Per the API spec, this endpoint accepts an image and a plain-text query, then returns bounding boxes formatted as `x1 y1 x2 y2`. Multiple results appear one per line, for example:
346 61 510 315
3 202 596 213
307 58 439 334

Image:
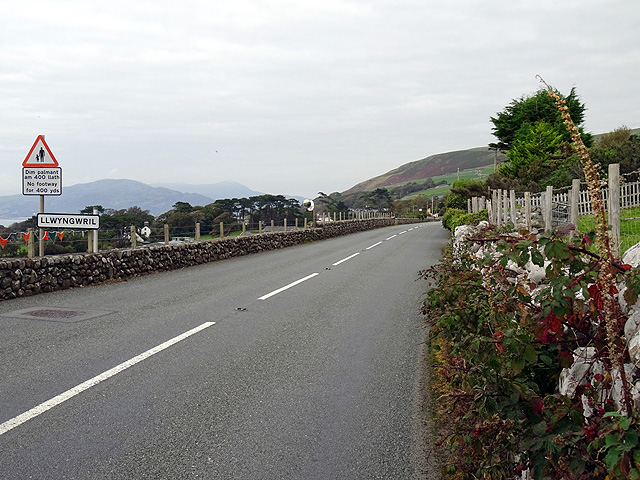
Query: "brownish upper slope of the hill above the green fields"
342 147 506 196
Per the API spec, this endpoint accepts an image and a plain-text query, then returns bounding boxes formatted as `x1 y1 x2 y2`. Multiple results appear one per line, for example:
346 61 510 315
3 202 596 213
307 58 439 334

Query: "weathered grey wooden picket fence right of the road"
468 164 640 256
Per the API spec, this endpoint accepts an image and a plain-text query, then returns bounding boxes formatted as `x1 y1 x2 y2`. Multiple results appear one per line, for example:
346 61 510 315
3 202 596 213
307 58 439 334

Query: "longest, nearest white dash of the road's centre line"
0 322 215 435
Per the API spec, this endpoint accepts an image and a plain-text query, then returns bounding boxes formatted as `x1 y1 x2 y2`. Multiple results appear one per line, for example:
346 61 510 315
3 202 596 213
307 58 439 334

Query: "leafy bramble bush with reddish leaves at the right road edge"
424 231 640 480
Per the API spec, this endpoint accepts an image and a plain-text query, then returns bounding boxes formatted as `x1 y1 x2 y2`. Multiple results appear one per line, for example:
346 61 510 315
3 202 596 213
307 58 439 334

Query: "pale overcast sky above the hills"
0 0 640 198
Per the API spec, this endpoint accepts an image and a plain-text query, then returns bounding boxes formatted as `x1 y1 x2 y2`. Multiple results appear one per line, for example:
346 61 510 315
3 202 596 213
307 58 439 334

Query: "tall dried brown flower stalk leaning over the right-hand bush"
538 76 631 413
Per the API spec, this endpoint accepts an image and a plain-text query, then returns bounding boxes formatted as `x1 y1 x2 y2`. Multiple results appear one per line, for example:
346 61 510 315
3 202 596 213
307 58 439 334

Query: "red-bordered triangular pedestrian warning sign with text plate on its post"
22 135 62 257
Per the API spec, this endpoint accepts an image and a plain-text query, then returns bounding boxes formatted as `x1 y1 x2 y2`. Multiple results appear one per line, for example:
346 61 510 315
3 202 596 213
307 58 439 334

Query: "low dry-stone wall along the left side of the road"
0 218 416 301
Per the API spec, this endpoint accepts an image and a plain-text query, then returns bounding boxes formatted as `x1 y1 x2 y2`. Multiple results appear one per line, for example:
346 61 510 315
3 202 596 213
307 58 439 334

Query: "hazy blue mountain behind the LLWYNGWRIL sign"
0 180 215 218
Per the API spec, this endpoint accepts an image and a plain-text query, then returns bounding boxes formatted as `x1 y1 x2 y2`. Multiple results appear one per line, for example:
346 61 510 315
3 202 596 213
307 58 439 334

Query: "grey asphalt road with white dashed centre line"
0 223 448 480
